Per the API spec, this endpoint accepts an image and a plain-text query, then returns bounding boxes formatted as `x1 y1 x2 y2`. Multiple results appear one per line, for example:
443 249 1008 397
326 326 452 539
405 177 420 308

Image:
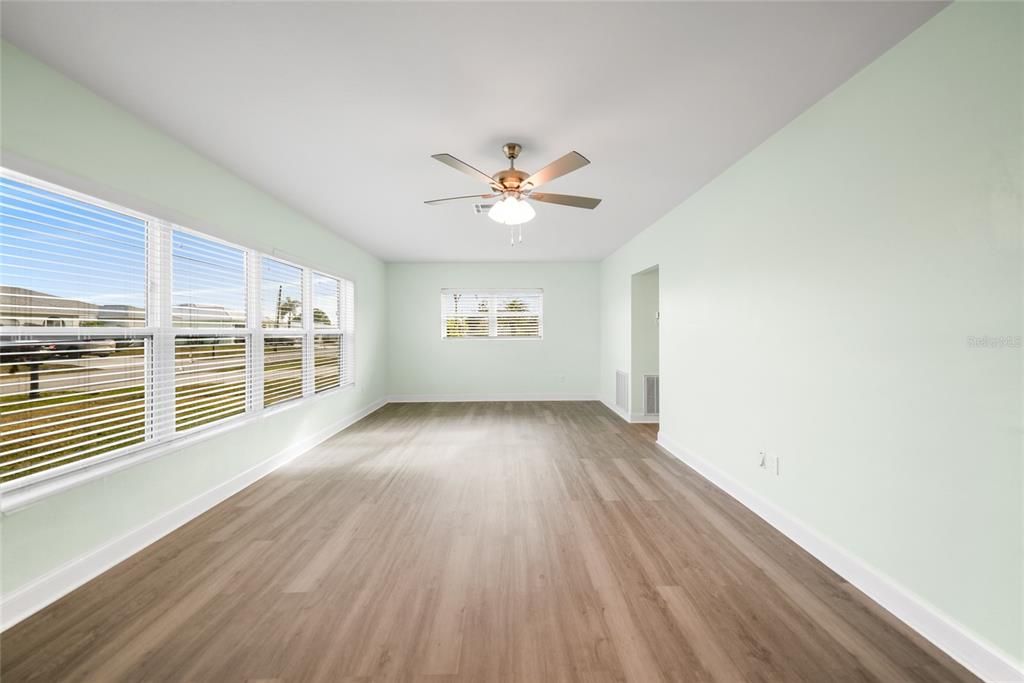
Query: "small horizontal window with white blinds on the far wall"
441 290 544 339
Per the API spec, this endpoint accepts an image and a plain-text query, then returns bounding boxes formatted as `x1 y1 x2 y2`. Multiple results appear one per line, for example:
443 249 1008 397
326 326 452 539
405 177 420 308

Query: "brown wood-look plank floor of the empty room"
2 402 976 683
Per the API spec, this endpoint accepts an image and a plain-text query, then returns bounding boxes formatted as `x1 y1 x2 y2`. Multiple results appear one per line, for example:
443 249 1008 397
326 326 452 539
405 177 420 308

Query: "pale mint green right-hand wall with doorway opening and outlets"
600 3 1024 663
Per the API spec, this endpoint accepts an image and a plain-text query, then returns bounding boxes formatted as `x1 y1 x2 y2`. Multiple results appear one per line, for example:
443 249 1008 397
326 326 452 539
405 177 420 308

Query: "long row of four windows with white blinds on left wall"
0 169 354 488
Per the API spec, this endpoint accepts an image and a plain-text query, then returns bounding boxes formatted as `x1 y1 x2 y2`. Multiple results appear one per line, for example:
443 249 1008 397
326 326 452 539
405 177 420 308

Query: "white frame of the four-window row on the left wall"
0 167 355 501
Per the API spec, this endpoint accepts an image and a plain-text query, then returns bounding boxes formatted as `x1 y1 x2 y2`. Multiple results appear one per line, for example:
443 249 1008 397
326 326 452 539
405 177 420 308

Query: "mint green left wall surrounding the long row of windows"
0 44 387 592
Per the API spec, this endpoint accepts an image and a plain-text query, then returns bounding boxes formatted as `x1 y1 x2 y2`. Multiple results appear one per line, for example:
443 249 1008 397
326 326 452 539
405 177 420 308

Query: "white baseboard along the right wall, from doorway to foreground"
657 432 1024 683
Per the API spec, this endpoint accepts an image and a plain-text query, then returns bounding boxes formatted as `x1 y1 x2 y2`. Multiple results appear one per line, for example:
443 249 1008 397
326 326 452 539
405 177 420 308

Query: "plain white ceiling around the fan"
2 2 944 261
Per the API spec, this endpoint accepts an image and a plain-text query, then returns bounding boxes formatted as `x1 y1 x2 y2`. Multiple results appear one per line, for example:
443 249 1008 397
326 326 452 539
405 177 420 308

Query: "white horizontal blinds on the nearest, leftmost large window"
0 177 152 481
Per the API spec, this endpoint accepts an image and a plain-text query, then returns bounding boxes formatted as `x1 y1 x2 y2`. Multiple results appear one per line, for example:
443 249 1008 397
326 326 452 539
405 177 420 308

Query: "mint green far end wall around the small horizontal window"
388 263 598 398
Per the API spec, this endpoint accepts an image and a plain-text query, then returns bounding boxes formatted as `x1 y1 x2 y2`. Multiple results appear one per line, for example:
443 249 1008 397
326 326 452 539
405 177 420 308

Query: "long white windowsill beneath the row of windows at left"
0 382 355 514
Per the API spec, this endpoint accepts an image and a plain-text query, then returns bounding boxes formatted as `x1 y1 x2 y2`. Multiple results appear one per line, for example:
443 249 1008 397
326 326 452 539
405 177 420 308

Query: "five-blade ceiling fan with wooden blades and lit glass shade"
424 142 601 225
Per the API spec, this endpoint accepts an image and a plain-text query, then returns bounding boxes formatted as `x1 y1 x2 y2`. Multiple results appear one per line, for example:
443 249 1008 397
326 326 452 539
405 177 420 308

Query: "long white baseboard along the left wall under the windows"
0 399 387 631
